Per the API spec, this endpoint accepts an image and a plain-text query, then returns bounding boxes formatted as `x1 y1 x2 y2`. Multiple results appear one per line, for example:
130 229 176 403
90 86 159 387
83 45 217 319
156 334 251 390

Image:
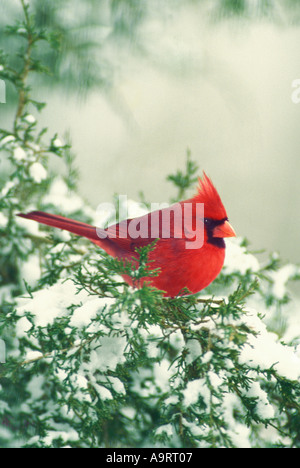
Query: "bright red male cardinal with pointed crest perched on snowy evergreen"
18 173 235 297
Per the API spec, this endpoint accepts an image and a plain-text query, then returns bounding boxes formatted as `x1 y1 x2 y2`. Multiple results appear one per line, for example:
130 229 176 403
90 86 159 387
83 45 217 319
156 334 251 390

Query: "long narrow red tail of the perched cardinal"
17 211 99 242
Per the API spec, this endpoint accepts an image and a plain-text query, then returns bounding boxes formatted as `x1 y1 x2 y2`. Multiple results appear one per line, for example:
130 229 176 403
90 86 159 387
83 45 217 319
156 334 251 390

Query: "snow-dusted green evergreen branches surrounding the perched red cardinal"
0 0 300 448
